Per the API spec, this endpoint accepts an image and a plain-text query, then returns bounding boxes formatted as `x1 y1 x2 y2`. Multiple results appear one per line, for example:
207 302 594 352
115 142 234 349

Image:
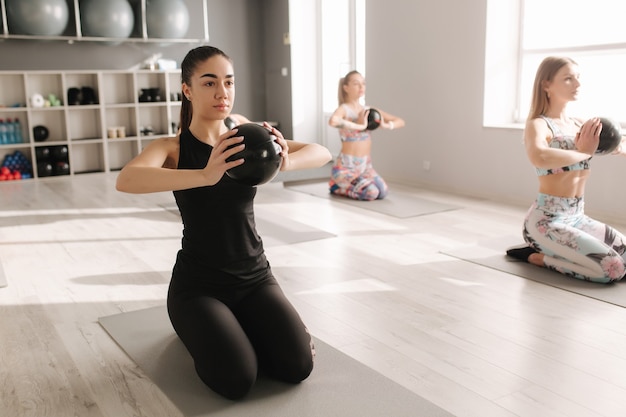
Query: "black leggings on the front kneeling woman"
167 280 314 400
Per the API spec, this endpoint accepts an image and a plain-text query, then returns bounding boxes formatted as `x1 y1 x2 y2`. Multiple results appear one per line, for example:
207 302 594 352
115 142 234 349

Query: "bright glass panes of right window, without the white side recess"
519 0 626 121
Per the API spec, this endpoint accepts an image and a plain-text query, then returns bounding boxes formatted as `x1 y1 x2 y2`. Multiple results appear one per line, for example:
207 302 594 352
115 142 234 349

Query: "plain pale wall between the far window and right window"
366 0 626 223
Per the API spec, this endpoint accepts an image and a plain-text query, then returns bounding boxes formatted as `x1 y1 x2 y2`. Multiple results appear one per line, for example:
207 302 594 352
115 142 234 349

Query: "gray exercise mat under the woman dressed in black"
99 306 452 417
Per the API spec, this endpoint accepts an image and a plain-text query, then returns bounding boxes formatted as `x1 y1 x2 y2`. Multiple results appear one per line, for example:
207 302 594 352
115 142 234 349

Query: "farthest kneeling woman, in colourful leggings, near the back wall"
328 71 404 200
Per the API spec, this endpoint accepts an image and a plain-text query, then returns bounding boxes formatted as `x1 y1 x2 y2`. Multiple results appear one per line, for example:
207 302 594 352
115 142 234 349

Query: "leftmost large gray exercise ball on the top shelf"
6 0 69 36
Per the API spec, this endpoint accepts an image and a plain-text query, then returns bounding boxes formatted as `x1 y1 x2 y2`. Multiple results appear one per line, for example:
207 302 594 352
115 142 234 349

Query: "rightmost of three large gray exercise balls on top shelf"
146 0 189 39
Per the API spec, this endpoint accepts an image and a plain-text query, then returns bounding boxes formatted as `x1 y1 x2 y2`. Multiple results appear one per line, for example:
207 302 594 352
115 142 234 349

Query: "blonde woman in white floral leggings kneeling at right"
507 57 626 283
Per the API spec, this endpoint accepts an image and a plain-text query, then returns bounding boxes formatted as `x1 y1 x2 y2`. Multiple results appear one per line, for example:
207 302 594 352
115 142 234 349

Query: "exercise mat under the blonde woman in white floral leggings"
442 236 626 307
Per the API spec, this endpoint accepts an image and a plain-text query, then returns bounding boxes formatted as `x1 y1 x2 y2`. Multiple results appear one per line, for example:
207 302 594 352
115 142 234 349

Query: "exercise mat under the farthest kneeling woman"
285 181 460 219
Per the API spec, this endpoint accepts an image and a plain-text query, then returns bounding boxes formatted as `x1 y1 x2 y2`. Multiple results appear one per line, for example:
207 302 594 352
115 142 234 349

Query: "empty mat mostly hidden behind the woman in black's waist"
162 204 337 247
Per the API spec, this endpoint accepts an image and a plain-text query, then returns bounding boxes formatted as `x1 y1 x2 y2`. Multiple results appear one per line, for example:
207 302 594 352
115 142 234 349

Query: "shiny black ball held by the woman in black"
226 123 283 186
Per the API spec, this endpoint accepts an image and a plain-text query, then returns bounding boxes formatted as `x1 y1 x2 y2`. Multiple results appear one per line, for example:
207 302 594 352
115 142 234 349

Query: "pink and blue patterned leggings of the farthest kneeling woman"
328 153 388 201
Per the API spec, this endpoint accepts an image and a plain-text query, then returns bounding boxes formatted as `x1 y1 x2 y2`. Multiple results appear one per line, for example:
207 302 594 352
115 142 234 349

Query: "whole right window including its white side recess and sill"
484 0 626 126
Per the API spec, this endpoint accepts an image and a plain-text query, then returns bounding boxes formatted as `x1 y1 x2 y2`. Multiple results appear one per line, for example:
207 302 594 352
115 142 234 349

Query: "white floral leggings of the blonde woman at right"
523 193 626 283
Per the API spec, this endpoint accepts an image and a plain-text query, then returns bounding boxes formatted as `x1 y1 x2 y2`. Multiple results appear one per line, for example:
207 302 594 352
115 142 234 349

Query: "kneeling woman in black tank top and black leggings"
116 46 332 399
